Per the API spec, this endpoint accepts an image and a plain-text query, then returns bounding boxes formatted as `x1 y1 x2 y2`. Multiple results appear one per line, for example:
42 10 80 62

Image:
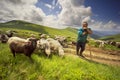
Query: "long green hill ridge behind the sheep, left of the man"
0 20 77 38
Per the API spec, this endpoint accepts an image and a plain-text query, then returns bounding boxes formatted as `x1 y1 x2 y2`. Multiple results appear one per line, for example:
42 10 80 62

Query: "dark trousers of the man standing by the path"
76 41 86 55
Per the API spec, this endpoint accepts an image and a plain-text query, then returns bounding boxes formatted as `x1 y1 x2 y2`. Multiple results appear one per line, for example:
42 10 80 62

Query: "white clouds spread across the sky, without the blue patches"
0 0 119 30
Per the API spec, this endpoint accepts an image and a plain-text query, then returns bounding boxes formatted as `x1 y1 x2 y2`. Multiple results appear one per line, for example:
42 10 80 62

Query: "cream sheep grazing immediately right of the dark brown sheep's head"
37 38 51 57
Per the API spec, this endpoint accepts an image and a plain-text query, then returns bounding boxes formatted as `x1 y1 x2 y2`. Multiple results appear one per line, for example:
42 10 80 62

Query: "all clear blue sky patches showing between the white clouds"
36 0 120 24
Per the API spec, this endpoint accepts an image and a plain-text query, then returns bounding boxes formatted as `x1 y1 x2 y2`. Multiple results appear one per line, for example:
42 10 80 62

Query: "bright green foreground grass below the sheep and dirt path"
0 44 120 80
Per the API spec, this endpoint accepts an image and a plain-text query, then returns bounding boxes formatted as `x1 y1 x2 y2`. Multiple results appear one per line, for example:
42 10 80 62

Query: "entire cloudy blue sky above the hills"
0 0 120 31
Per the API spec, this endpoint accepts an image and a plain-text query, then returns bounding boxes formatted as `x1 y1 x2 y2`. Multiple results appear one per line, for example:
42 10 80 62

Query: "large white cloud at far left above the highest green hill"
0 0 45 23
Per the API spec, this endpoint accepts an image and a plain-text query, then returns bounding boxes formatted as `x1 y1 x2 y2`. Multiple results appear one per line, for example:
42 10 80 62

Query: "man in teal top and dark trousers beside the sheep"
76 22 92 57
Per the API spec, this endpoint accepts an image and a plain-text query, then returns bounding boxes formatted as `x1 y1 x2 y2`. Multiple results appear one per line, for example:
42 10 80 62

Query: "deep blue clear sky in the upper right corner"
84 0 120 23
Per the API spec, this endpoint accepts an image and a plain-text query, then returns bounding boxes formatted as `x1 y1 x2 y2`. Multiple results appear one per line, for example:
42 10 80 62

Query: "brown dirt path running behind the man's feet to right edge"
65 46 120 66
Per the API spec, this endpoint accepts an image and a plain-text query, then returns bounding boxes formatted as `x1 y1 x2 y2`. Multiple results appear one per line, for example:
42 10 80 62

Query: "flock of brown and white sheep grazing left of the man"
0 31 72 58
